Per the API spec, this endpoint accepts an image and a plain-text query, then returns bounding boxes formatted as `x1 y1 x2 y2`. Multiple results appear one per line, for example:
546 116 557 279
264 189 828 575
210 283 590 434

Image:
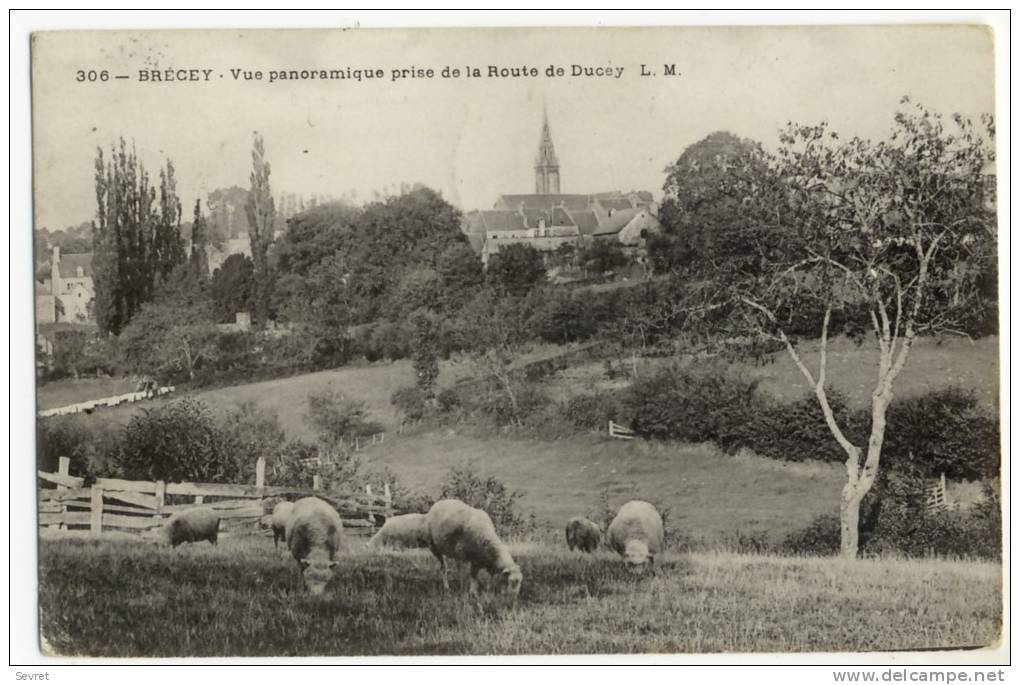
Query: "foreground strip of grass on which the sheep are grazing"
40 536 1002 656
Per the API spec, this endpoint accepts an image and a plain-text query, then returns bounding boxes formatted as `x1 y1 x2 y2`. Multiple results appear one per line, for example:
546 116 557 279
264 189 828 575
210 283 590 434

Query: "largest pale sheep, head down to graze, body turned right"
426 499 523 599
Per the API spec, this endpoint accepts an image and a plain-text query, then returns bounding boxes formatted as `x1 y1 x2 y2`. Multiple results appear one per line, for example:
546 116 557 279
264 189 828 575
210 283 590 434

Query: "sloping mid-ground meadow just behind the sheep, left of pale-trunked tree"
363 431 846 543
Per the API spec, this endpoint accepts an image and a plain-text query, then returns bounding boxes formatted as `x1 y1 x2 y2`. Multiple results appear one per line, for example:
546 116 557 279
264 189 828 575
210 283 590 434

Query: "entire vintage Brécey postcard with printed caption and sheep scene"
17 17 1009 664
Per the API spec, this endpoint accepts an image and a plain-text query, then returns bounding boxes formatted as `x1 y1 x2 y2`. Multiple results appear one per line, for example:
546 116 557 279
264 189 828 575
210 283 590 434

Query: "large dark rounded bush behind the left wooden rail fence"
116 399 242 483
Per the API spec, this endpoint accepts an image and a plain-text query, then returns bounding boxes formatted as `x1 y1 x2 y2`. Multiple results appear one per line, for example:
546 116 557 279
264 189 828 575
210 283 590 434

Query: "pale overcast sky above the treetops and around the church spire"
33 27 993 229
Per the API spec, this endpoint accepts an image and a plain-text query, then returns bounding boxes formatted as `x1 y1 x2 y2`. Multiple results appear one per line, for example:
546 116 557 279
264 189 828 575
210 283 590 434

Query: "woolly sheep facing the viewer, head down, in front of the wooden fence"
286 497 344 594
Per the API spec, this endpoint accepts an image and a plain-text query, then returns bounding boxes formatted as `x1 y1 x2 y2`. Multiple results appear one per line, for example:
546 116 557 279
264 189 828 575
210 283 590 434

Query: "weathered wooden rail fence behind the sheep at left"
37 457 393 537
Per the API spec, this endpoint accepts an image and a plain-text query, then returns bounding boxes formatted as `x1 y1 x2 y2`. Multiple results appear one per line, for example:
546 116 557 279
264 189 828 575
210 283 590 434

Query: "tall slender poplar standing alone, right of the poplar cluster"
245 133 276 326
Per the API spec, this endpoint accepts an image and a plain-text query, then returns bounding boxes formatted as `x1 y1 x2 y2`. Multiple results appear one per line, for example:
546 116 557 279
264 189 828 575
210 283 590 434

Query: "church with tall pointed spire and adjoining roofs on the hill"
462 113 662 263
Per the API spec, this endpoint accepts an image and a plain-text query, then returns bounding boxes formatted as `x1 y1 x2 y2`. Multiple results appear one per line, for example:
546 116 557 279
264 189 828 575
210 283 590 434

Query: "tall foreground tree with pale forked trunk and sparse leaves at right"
719 99 996 557
